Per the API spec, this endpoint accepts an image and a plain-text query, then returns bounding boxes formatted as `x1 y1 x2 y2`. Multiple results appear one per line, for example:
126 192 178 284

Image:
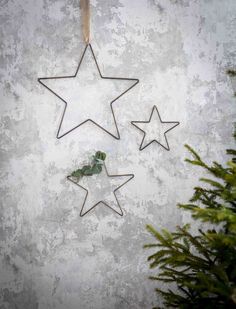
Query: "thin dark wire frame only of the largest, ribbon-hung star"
38 43 139 140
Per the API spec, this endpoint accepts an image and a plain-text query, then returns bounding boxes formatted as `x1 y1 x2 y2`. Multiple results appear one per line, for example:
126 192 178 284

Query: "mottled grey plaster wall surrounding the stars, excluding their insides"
0 0 236 309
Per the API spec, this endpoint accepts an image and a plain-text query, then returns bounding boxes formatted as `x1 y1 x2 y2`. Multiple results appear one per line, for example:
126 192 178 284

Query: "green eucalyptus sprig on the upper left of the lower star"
71 151 106 179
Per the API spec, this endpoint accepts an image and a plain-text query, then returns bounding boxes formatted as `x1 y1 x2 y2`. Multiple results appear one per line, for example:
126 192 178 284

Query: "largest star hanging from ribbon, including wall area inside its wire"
38 44 139 139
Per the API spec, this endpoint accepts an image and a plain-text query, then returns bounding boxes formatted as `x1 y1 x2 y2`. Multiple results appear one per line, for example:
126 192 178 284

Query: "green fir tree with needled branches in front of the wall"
145 74 236 309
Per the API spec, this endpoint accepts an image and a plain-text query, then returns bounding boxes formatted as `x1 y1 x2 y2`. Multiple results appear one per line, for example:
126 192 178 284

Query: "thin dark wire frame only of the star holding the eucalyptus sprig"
66 164 134 217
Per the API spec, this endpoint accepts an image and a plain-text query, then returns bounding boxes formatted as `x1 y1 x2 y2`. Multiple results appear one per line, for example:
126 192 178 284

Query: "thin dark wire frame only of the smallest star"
131 105 180 151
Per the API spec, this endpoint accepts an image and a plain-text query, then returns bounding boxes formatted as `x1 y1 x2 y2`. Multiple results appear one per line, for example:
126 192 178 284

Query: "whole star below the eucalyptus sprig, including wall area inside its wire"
67 164 134 217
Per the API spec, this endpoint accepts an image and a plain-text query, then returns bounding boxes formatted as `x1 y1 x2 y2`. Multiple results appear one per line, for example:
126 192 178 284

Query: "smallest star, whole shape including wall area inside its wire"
131 105 179 150
